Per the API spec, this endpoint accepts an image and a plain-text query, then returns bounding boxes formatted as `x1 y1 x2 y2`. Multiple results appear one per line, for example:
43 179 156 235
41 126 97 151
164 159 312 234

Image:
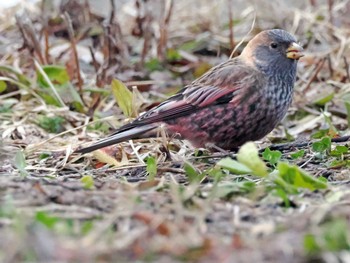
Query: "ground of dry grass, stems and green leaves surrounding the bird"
0 0 350 262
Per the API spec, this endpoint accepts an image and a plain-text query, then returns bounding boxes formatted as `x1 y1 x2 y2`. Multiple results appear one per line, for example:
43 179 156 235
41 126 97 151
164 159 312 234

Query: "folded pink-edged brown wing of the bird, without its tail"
114 60 260 131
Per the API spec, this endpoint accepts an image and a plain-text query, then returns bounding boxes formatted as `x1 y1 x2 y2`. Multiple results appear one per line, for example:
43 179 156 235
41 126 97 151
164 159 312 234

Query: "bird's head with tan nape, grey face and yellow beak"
241 29 304 74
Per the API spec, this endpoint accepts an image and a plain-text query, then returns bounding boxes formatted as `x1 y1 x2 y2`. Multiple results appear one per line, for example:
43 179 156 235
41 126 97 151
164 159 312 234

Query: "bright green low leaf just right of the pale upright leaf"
277 162 327 191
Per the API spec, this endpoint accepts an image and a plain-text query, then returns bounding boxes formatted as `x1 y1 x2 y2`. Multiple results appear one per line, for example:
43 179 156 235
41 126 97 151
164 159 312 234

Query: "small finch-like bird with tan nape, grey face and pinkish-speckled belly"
76 29 304 153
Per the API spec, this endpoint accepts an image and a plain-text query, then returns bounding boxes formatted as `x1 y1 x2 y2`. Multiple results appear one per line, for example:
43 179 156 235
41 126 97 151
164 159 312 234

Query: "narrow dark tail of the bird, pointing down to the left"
75 124 158 153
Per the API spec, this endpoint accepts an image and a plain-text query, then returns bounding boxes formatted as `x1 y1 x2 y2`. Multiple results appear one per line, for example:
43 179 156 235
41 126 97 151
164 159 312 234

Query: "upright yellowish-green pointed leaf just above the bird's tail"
111 79 134 117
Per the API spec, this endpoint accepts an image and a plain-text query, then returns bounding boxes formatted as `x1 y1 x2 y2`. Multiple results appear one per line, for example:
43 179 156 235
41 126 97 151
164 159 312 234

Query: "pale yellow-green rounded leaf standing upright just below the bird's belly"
237 142 268 177
